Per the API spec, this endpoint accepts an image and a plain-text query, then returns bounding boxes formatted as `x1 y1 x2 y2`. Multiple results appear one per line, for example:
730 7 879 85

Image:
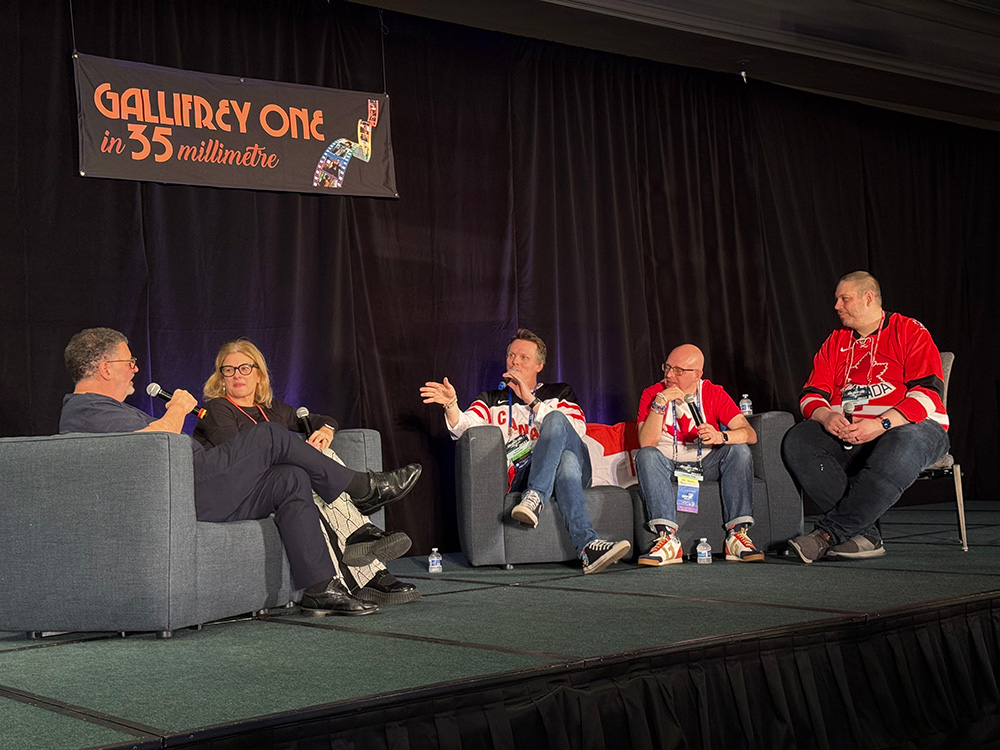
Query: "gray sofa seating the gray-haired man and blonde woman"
0 430 382 637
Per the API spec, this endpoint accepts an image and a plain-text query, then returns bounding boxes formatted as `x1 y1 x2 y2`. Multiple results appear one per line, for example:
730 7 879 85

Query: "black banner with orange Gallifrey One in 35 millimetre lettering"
75 55 398 198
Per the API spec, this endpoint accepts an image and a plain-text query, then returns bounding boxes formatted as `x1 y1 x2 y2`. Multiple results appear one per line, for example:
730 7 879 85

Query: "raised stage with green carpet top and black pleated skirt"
0 502 1000 750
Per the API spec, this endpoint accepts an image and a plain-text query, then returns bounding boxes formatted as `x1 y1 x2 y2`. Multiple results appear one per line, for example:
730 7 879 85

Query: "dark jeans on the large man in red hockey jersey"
781 419 951 544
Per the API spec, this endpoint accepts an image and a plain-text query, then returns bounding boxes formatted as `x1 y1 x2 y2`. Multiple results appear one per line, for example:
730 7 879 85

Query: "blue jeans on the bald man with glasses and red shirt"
635 444 753 533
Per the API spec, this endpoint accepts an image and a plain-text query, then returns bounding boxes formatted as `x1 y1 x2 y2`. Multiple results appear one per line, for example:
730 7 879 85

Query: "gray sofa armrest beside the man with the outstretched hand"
455 425 507 565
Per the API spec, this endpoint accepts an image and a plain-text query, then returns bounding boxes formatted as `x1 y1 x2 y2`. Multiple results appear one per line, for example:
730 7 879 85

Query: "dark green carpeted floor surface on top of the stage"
0 502 1000 750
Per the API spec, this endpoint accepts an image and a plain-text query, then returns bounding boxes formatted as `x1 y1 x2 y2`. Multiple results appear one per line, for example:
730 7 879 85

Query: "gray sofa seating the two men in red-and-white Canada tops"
455 412 802 565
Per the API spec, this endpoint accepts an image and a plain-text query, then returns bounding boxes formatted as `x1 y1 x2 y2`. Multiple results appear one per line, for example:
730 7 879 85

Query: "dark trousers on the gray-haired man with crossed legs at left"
194 422 355 588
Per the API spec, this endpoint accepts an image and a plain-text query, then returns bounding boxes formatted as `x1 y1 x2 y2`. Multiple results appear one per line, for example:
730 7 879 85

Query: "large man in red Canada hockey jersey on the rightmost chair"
782 271 949 563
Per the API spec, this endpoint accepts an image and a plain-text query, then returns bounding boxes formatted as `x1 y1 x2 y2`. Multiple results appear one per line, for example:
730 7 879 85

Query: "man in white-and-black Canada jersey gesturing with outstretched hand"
420 328 632 573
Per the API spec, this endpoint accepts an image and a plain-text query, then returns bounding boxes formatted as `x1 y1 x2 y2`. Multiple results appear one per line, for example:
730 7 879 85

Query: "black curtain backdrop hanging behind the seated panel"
0 0 1000 552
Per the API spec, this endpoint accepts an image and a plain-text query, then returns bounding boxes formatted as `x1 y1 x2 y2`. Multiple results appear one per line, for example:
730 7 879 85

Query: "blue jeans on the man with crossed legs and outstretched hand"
528 412 598 554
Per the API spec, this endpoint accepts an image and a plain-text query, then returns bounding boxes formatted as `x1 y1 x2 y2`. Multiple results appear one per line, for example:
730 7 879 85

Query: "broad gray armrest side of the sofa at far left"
0 432 196 630
